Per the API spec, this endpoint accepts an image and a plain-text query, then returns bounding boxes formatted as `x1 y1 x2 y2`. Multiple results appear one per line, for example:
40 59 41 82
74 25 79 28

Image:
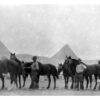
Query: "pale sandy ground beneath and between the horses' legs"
0 76 100 96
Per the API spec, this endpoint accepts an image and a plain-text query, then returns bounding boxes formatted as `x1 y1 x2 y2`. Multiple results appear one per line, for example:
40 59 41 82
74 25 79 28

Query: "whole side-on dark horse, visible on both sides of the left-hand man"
23 62 58 89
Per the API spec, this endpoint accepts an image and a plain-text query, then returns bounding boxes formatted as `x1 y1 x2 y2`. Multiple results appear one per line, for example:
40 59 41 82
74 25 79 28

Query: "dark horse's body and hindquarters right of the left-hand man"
34 62 59 89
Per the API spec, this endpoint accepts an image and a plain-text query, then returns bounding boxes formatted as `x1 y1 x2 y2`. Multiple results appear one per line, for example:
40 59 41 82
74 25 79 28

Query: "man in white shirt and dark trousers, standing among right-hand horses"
75 59 86 90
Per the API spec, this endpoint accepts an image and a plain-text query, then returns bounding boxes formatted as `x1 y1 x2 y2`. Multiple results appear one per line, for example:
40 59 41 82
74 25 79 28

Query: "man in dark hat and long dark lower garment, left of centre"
30 56 39 89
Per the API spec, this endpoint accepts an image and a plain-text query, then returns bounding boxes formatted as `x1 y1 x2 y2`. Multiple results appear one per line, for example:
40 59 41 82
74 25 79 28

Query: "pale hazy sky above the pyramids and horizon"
0 5 100 59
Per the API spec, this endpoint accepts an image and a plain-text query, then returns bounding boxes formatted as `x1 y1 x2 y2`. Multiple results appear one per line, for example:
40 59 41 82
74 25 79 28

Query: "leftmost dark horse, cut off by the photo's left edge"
0 58 19 89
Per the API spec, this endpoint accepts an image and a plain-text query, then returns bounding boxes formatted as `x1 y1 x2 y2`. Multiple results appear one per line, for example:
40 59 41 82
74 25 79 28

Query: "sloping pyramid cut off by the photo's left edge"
0 41 10 59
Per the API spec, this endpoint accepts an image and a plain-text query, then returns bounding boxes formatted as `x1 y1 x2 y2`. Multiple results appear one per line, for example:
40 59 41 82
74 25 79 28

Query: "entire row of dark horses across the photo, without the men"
0 53 100 90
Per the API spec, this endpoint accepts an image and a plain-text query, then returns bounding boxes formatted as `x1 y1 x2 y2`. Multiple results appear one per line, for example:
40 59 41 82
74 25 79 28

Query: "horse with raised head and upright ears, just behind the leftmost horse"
10 53 23 88
